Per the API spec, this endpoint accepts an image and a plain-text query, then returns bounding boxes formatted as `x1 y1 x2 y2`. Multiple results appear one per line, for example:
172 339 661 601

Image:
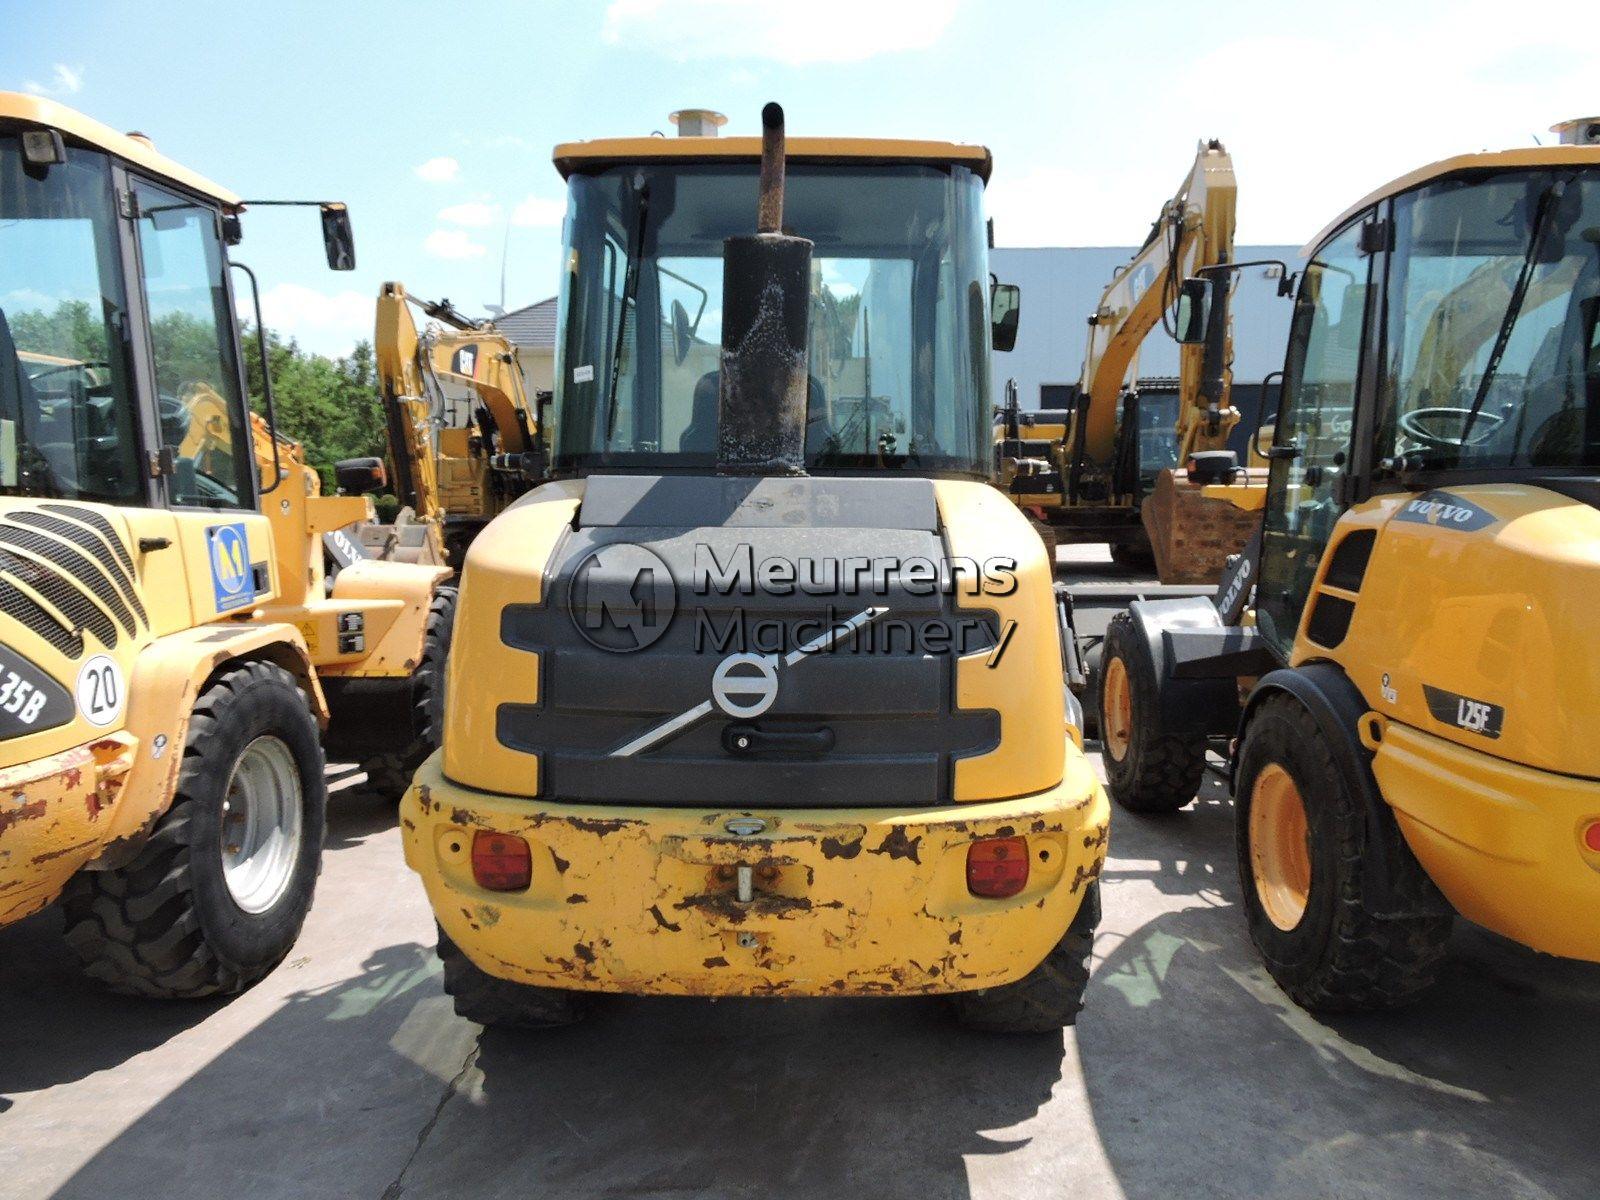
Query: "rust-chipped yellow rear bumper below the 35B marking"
0 734 133 925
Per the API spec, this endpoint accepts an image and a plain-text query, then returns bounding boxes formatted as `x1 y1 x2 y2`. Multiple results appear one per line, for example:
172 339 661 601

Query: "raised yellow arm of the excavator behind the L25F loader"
1069 141 1238 464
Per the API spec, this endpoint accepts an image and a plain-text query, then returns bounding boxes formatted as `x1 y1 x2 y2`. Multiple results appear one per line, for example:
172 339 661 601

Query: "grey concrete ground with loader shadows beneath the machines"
0 553 1600 1200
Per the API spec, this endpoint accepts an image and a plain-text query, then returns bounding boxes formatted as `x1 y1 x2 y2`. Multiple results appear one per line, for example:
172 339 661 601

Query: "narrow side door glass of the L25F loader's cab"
1256 222 1371 656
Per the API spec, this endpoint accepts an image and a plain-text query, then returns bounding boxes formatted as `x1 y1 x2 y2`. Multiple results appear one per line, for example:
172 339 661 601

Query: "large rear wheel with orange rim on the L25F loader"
1235 696 1453 1013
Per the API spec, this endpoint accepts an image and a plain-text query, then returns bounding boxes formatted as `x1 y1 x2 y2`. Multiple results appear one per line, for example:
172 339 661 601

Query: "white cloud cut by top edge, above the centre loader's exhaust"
602 0 960 66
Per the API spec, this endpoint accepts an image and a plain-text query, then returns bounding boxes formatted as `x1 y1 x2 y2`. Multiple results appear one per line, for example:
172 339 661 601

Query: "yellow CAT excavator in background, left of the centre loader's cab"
353 283 549 571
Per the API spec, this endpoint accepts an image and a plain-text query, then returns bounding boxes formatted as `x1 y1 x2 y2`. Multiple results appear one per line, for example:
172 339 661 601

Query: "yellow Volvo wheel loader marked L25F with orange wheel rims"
1101 120 1600 1010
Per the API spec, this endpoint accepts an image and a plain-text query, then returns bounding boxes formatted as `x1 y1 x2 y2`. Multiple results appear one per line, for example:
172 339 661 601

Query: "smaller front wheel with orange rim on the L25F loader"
1099 613 1206 813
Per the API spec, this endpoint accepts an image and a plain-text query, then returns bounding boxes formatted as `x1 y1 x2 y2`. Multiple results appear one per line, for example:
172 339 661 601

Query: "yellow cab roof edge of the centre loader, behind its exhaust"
552 138 992 182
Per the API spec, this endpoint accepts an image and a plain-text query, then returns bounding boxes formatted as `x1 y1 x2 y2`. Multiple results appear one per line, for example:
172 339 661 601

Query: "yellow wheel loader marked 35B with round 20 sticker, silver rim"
0 93 445 997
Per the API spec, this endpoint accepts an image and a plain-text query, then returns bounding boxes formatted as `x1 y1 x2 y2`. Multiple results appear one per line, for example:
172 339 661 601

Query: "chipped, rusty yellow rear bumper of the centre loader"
400 747 1109 995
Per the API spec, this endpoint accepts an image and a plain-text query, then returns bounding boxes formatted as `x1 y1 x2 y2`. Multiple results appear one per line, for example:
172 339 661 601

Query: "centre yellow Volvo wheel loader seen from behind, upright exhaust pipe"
402 104 1107 1030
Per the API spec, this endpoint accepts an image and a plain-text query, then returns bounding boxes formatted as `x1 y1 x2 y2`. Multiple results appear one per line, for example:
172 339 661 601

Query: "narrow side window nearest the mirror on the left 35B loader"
134 182 254 509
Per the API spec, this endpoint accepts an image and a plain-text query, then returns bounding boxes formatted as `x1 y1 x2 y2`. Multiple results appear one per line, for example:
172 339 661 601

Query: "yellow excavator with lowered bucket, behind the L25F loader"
995 141 1261 584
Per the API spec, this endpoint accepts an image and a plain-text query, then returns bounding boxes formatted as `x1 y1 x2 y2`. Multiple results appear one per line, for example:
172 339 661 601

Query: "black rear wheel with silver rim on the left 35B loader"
64 662 328 997
